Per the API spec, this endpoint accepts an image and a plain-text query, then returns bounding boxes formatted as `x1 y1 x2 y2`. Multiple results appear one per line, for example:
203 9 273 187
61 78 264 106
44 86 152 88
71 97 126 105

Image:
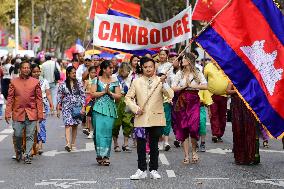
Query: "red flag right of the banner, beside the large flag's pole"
192 0 228 21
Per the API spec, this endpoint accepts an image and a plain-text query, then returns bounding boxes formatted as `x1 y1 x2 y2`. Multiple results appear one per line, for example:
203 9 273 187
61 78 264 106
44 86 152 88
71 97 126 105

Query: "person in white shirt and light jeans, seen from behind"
41 54 60 107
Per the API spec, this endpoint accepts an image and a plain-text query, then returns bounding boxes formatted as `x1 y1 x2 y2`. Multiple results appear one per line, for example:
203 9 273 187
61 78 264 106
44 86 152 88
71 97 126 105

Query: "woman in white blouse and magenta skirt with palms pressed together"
172 54 207 164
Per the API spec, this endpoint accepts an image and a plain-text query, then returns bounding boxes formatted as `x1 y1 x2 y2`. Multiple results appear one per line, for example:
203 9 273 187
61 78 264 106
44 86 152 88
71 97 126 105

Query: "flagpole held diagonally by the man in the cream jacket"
138 0 233 110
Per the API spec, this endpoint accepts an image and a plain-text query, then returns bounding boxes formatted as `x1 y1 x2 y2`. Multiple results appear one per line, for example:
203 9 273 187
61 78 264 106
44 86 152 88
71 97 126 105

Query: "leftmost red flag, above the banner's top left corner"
89 0 112 19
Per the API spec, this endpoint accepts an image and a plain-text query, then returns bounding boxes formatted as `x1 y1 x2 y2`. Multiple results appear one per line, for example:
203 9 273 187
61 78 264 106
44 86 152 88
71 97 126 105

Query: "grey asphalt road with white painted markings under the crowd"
0 117 284 189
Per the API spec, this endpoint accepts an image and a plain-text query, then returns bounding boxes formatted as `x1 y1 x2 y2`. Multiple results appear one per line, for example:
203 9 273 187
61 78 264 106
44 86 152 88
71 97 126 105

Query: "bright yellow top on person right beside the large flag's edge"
204 63 229 96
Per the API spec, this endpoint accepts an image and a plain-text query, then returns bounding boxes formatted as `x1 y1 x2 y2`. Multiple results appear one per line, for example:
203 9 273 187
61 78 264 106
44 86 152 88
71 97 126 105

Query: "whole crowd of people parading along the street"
0 48 284 180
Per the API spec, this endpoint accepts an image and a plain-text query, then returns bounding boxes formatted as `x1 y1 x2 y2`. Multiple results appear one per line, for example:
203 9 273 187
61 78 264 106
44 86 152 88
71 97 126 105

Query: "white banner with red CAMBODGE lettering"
93 7 192 50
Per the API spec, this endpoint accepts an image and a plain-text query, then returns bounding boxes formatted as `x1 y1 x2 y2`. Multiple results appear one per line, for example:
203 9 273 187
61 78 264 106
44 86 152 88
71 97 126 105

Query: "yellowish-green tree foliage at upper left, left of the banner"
0 0 90 56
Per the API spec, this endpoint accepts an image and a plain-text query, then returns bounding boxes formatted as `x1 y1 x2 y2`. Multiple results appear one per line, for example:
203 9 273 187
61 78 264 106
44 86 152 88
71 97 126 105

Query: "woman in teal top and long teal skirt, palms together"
91 60 121 166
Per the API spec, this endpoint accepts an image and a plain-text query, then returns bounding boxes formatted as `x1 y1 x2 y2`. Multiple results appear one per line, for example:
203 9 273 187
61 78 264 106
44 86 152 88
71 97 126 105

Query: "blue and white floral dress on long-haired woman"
57 82 85 126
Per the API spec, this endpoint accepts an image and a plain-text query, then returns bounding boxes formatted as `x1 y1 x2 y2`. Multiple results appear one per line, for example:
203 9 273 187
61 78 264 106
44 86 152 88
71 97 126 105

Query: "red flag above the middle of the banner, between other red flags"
110 0 141 18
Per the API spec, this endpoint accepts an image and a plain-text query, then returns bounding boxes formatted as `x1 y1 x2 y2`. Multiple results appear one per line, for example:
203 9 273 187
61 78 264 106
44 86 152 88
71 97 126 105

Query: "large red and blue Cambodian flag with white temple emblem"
197 0 284 138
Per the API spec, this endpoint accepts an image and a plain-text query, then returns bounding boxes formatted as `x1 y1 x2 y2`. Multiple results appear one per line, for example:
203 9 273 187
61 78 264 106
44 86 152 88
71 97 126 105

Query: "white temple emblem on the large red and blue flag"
241 40 283 95
